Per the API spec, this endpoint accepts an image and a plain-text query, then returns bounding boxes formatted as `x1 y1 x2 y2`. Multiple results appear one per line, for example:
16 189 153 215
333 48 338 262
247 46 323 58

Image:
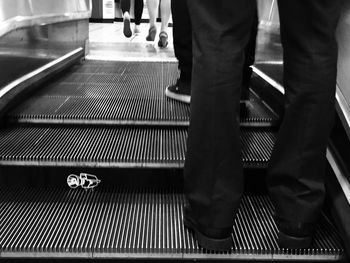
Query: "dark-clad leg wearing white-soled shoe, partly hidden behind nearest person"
165 0 192 103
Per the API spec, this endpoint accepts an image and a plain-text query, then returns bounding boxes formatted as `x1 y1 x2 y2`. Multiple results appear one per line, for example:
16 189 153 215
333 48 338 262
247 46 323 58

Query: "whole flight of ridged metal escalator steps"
0 61 345 262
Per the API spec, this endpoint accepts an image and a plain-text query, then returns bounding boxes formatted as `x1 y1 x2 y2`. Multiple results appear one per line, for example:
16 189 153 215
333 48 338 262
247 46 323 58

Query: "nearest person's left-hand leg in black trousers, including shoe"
184 0 255 250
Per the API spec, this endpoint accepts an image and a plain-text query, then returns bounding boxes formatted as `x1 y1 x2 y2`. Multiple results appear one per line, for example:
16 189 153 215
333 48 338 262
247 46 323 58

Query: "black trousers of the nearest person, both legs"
184 0 342 231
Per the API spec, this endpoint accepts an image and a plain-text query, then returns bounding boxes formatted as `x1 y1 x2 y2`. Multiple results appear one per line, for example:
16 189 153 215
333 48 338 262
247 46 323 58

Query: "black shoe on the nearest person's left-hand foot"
184 205 233 251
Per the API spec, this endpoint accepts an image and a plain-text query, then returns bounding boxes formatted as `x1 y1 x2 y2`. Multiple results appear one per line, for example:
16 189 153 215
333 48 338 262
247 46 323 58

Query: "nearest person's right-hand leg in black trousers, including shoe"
267 0 342 248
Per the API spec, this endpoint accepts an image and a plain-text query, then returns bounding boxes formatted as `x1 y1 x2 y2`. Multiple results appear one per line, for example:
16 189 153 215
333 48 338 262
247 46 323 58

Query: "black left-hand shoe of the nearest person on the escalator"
184 218 233 251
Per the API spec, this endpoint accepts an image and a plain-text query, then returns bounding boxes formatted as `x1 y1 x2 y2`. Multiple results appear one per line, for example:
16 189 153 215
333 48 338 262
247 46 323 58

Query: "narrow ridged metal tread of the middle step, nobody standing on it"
0 126 275 168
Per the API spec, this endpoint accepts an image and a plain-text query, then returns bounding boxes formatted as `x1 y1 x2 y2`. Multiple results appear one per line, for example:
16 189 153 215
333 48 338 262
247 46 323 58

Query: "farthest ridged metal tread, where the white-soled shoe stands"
8 62 278 126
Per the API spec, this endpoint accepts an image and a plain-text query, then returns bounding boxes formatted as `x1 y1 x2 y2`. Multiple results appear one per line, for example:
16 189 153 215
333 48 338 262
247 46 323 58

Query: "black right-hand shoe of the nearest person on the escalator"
275 218 314 249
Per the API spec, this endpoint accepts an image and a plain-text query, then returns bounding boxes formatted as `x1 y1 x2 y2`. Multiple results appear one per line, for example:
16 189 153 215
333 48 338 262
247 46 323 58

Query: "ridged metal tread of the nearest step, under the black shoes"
0 188 343 261
